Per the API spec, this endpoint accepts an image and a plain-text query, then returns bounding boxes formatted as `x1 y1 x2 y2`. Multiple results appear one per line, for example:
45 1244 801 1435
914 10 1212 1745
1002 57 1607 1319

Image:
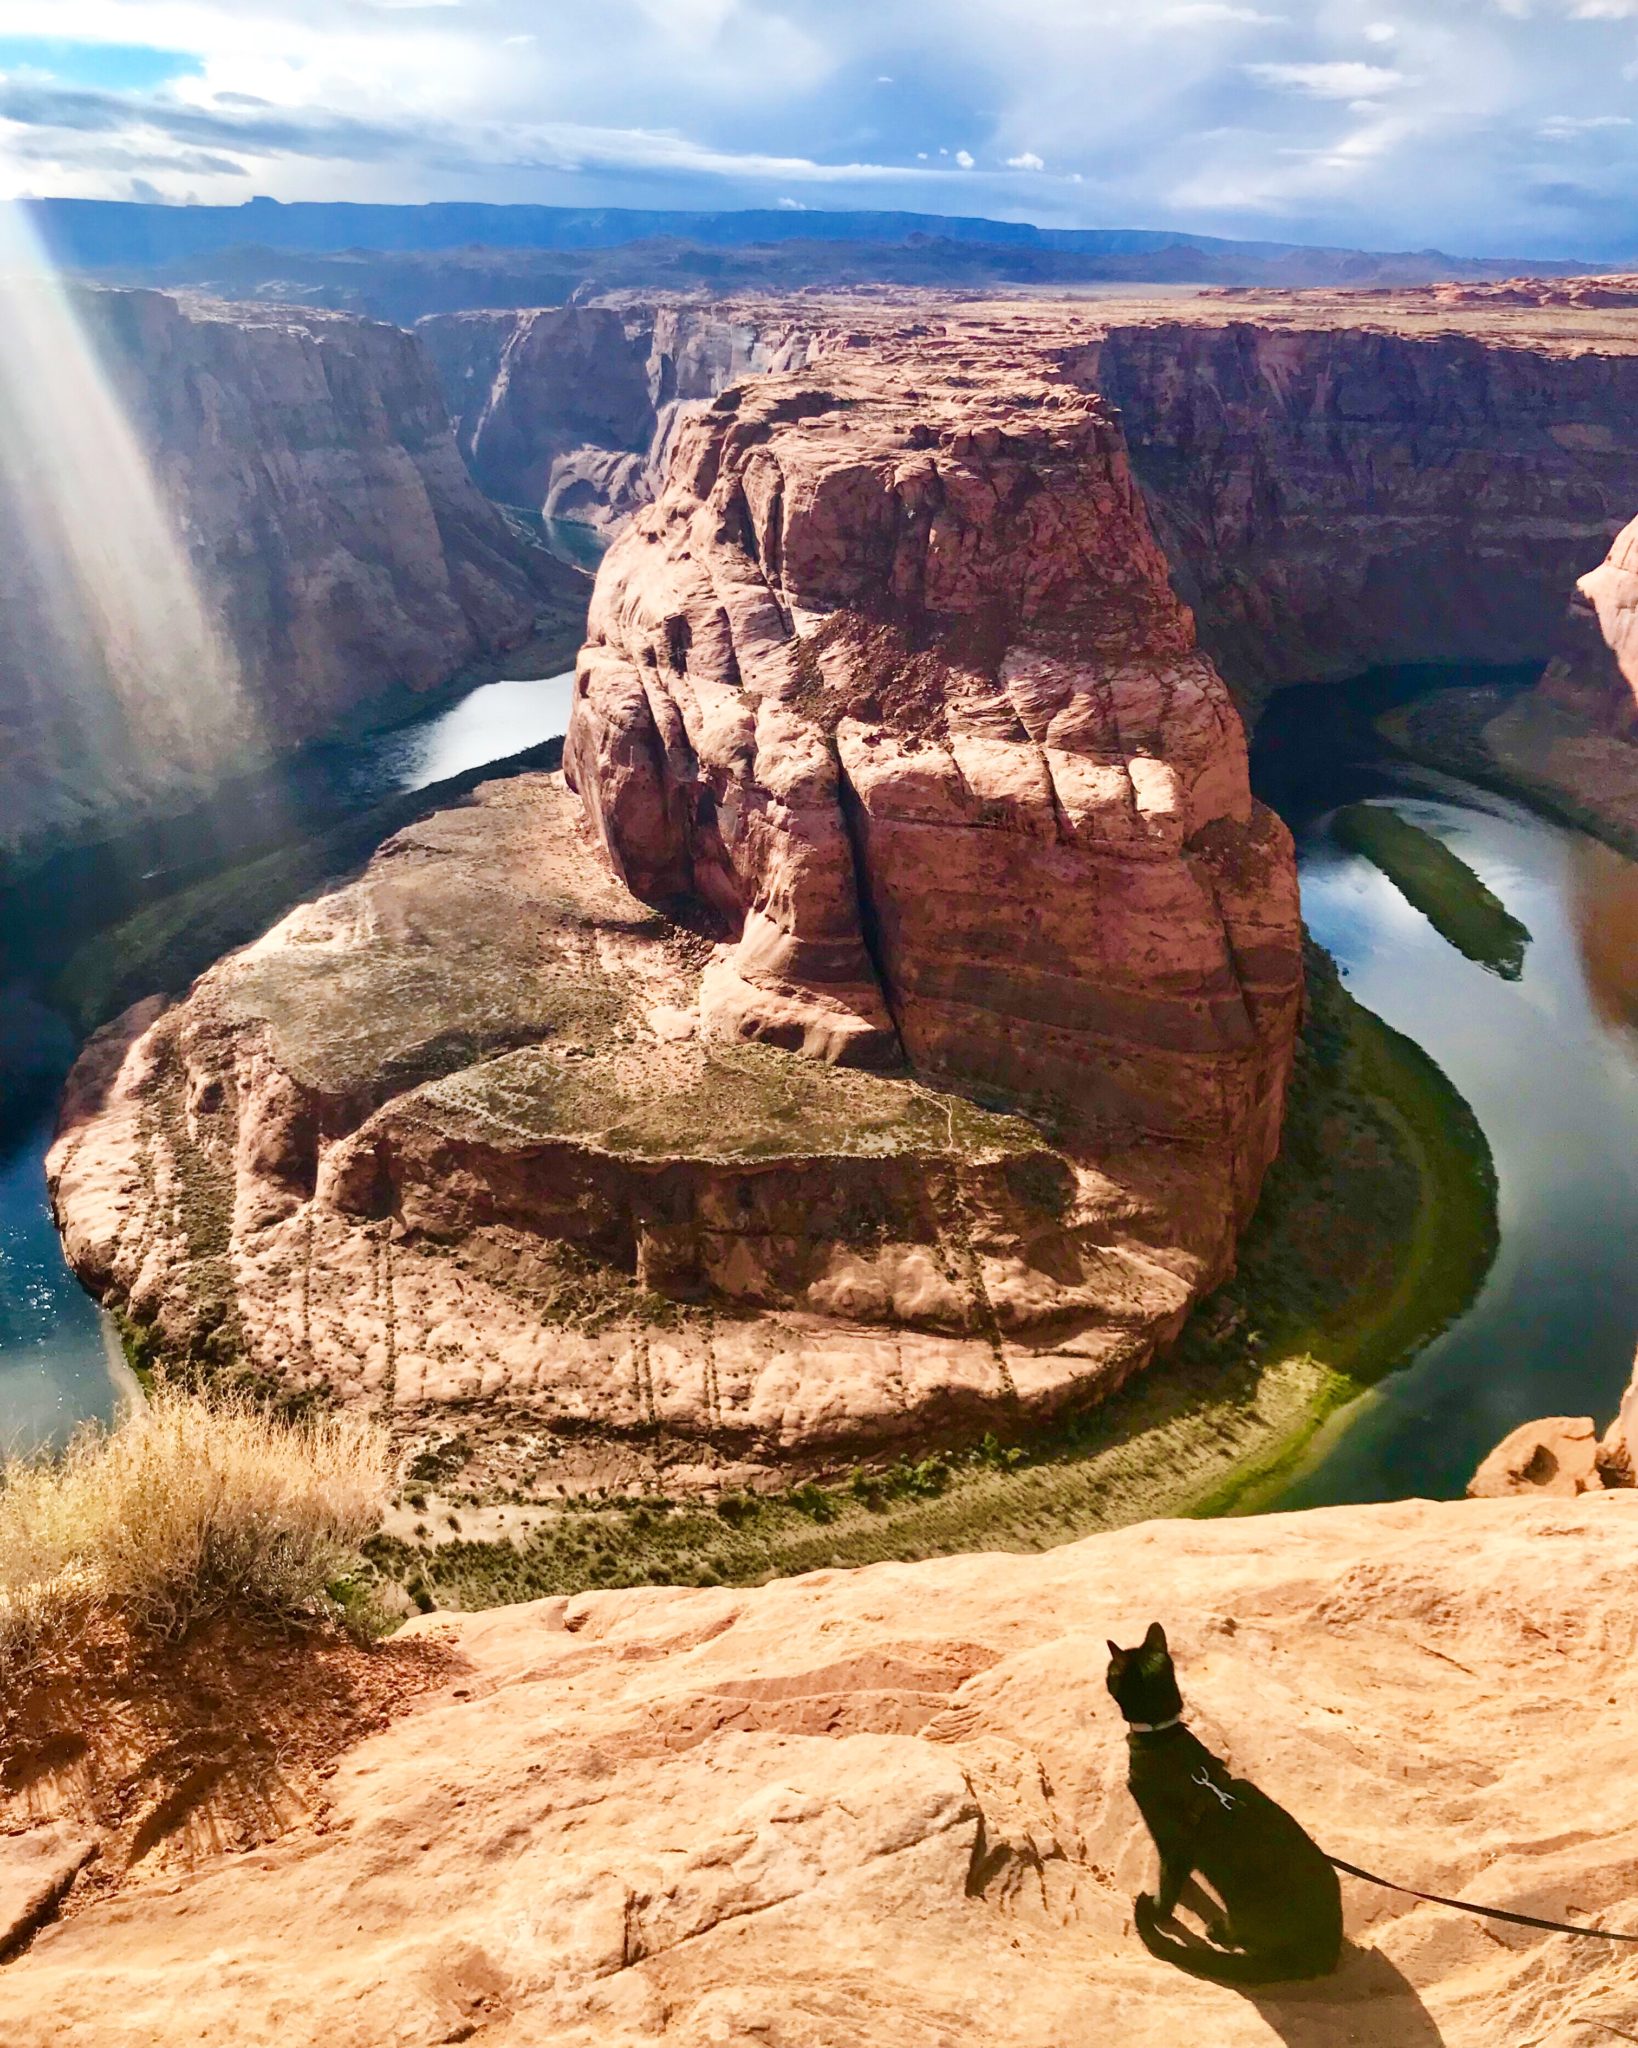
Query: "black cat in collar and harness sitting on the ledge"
1108 1622 1343 1985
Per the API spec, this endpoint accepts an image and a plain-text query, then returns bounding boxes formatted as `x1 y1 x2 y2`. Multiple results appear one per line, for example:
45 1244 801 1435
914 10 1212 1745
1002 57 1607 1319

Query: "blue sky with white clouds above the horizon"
0 0 1638 260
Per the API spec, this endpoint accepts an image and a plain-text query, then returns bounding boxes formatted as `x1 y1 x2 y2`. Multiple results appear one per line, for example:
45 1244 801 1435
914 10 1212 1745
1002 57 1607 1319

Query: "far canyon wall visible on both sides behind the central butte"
420 281 1638 705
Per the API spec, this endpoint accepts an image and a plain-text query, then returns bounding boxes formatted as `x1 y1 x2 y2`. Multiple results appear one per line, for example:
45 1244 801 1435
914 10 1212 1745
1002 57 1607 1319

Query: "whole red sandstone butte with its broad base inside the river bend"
49 317 1300 1483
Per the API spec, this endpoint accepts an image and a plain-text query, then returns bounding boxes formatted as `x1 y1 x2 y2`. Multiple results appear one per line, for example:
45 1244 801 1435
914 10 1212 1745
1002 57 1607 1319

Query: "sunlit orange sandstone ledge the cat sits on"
12 1495 1638 2048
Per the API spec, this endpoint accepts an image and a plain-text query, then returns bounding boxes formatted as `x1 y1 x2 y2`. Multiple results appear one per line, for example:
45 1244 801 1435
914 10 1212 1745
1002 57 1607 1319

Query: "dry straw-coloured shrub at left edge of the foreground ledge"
0 1382 389 1671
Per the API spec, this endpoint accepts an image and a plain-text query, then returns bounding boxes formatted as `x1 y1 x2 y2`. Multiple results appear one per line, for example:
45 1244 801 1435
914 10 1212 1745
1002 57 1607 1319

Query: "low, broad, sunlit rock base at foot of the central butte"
47 776 1294 1489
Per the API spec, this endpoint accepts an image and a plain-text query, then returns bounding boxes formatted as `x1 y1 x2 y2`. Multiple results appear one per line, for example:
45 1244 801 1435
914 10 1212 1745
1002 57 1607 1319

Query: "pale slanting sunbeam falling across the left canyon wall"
0 188 260 842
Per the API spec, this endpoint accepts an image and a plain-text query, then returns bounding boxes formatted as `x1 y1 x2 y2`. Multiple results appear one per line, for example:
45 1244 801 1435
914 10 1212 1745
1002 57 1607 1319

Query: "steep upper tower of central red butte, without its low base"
565 330 1300 1204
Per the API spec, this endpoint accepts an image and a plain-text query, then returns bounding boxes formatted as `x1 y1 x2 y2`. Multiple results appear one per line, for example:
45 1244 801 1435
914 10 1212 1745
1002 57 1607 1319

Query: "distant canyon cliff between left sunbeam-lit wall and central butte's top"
416 299 821 532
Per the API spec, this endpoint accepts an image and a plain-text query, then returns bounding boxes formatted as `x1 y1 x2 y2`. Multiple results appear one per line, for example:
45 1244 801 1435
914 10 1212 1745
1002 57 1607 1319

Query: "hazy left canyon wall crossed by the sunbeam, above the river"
0 289 579 850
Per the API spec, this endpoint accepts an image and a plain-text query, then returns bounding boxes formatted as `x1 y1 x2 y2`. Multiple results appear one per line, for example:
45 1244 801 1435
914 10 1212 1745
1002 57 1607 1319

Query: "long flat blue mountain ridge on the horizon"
23 199 1585 283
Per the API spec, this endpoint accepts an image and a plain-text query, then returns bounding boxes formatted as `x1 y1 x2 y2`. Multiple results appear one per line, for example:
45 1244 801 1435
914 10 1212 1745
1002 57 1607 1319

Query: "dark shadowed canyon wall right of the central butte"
1079 319 1638 700
